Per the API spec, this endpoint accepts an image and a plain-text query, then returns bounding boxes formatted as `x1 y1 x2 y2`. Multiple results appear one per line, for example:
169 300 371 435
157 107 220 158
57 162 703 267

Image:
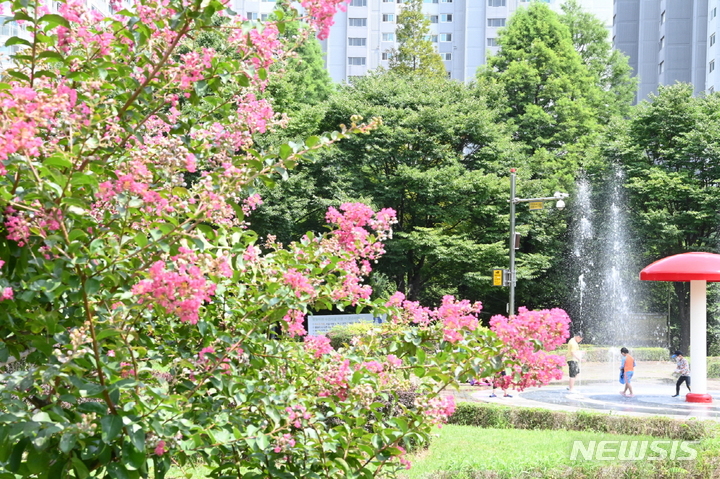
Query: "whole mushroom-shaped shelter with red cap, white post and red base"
640 253 720 403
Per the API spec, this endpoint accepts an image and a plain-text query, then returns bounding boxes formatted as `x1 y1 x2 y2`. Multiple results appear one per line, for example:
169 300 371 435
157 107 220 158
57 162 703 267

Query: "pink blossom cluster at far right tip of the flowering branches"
490 307 570 390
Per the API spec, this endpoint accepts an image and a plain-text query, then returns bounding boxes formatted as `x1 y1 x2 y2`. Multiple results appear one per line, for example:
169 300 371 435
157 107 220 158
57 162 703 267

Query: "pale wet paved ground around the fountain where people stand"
453 361 720 420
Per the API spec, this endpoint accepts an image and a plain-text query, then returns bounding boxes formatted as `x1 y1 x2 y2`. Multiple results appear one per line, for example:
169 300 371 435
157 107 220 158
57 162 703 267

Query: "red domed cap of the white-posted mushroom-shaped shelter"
640 253 720 282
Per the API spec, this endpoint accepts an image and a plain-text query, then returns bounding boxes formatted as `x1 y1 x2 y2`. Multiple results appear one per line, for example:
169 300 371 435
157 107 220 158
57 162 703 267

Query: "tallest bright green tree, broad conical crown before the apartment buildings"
478 2 604 187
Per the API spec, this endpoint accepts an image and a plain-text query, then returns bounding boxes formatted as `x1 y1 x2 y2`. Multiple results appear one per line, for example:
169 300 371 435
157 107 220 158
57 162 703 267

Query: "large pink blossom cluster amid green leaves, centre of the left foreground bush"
132 248 216 324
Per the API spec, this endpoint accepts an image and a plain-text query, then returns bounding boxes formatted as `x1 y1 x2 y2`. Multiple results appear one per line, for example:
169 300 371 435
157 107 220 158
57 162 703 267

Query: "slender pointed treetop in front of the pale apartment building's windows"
389 0 447 78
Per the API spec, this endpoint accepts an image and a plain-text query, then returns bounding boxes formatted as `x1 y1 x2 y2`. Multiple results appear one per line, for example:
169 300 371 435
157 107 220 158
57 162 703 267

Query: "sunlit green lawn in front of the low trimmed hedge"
405 425 684 479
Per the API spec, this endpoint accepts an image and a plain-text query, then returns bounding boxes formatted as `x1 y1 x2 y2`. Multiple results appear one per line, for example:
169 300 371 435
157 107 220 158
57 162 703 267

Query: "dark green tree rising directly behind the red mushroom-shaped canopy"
610 84 720 351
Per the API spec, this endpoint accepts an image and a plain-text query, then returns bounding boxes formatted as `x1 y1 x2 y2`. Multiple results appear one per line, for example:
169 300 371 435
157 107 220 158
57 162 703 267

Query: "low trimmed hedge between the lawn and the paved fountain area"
448 403 720 441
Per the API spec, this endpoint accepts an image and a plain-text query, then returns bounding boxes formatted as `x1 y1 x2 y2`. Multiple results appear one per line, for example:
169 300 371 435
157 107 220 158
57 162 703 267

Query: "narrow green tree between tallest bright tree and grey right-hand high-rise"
560 0 637 119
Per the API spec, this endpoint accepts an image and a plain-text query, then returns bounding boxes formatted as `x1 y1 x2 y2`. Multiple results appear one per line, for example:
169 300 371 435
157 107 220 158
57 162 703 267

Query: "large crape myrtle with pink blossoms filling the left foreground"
0 0 569 479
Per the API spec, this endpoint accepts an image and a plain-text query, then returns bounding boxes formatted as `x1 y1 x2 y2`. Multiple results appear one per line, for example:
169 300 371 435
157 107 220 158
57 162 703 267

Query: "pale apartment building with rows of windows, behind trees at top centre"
235 0 612 82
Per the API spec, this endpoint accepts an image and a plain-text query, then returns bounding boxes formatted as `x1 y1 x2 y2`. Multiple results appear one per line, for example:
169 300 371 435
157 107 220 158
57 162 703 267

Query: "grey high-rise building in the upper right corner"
613 0 720 101
